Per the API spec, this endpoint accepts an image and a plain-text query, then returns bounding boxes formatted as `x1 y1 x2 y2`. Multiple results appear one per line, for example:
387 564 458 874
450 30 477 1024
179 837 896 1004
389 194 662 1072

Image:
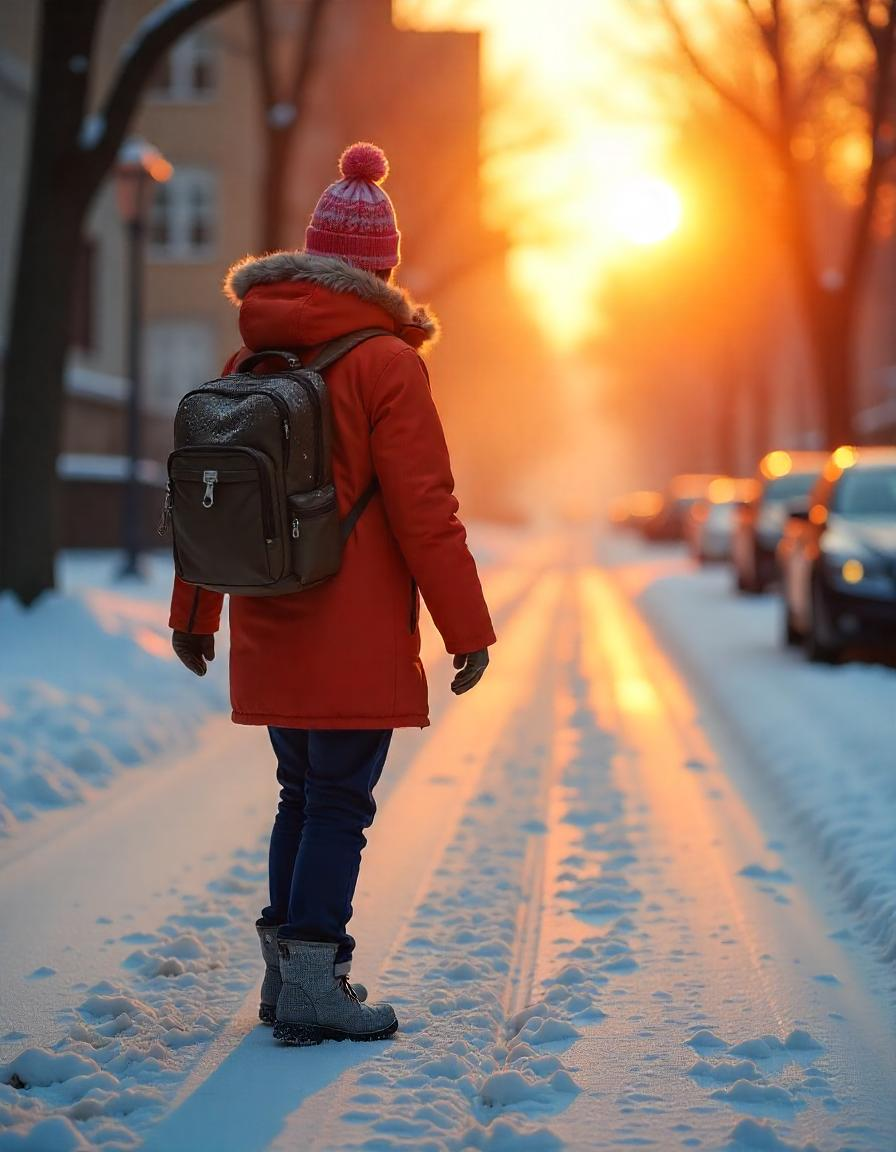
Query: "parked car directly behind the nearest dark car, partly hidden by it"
731 449 828 592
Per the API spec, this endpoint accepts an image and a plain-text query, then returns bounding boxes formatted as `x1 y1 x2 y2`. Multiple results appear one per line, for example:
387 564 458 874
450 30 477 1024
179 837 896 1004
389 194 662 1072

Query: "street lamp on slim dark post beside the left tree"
115 138 174 576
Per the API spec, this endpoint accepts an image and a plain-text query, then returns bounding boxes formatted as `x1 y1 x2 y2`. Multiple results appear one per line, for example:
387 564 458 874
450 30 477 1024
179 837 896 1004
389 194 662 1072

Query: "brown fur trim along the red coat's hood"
223 251 439 349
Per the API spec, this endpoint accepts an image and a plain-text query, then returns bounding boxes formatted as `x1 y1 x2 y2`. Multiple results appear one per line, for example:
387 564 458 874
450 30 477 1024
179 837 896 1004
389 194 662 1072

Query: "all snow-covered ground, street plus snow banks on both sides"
0 530 896 1152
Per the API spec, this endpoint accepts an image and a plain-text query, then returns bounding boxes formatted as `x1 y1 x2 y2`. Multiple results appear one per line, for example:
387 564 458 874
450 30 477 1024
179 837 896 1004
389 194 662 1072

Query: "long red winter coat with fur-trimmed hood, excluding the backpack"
169 252 495 728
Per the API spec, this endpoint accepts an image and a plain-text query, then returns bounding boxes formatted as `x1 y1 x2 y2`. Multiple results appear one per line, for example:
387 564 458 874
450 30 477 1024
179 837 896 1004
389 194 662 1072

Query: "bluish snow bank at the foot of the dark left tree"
0 554 227 835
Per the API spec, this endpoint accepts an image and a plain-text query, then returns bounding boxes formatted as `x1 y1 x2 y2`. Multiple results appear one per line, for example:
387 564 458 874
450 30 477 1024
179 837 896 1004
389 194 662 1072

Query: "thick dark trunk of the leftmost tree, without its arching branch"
0 0 99 604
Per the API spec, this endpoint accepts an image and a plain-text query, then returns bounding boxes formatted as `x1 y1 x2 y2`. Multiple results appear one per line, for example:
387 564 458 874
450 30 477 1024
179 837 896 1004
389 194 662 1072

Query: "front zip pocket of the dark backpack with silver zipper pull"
168 446 284 591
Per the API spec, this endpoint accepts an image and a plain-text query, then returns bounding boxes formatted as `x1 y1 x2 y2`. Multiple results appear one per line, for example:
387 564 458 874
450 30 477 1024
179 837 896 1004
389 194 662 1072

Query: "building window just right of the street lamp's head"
150 167 218 263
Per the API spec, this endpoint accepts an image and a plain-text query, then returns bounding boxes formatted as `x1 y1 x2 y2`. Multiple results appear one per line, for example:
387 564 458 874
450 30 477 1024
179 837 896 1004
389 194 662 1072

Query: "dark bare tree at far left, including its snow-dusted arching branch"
0 0 235 604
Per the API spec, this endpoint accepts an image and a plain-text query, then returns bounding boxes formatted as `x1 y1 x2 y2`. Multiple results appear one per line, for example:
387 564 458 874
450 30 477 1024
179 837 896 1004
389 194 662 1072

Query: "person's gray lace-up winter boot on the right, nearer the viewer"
274 940 398 1045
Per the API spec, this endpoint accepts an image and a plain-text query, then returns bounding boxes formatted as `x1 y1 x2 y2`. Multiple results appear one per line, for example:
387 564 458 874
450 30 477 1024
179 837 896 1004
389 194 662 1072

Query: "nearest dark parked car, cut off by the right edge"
779 447 896 661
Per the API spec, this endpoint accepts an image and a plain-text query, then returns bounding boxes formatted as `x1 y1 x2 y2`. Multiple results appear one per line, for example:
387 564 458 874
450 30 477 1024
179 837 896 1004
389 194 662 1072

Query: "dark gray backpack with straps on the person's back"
159 328 388 596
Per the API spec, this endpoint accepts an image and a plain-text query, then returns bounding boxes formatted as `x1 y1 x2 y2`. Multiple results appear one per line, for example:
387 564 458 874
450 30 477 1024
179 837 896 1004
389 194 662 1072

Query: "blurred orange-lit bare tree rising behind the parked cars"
650 0 896 445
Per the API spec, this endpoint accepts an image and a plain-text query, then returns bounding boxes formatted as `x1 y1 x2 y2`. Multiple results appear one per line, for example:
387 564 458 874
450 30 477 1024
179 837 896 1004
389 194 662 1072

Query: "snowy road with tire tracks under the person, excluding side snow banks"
0 538 896 1152
